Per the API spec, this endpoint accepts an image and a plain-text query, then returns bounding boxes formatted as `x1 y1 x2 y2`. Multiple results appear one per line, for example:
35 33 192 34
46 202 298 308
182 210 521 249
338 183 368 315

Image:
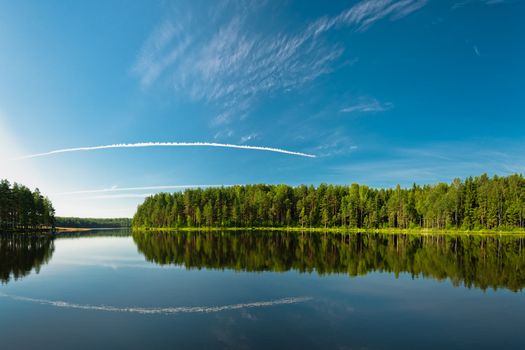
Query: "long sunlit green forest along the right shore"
133 174 525 230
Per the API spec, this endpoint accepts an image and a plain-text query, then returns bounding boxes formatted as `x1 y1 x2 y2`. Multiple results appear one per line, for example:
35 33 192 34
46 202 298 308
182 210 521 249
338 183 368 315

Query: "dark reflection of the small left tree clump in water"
0 234 55 283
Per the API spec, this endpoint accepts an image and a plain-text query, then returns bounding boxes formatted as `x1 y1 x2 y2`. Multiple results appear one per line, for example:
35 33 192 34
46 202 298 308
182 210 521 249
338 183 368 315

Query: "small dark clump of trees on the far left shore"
0 180 55 230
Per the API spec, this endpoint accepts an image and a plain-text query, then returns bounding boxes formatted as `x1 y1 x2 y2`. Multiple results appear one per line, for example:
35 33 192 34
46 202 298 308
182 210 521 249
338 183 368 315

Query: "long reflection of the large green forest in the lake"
133 231 525 291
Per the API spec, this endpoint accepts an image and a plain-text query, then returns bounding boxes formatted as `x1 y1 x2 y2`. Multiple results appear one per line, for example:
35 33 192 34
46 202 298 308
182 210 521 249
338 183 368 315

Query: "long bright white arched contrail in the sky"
17 142 316 160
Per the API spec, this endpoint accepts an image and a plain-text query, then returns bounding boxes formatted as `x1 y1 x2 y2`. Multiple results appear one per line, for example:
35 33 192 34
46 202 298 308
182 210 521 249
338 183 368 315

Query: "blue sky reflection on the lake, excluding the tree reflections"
0 231 525 349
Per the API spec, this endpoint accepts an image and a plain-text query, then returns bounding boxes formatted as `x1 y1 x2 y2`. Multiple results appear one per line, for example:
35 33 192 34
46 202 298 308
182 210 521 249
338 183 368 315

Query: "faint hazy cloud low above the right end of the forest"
332 139 525 187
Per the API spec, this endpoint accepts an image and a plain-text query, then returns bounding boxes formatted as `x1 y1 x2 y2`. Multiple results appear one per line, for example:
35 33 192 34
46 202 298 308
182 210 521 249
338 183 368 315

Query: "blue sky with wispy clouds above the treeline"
0 0 525 217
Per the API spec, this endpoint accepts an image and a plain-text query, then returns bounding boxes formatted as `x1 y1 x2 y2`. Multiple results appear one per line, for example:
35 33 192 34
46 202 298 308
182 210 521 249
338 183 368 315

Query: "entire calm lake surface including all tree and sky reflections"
0 231 525 349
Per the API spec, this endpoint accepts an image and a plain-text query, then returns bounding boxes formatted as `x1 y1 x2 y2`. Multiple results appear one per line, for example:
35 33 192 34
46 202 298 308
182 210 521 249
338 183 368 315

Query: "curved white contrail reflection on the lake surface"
0 293 312 315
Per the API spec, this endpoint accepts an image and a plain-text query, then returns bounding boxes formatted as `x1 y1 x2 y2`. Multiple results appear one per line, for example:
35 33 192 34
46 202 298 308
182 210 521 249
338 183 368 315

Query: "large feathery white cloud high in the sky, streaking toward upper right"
133 0 427 125
